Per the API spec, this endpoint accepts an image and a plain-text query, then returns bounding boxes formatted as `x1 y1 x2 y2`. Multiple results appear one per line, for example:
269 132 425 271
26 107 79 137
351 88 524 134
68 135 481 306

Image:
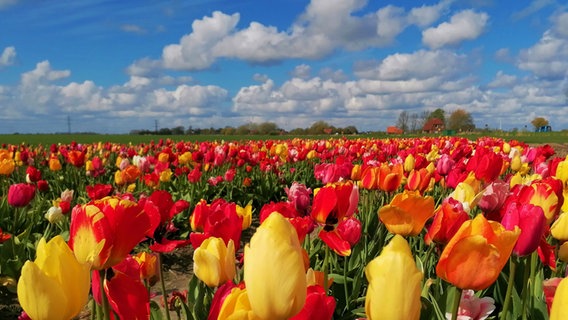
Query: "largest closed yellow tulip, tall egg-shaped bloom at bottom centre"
244 212 307 320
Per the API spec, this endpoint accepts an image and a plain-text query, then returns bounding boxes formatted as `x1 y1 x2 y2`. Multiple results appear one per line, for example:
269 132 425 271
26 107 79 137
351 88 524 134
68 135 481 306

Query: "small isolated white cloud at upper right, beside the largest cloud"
422 10 489 49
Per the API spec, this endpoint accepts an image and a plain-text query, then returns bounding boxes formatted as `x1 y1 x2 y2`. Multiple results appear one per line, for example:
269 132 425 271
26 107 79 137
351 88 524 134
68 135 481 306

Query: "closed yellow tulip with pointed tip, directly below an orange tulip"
365 235 423 320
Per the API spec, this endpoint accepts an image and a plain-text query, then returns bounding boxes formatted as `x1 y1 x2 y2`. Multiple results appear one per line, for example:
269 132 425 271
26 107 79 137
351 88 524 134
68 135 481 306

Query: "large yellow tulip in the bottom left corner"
18 236 91 320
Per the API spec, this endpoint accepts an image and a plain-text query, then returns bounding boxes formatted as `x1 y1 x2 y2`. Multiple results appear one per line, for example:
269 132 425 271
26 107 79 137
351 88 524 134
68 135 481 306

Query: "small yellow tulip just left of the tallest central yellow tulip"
193 237 236 287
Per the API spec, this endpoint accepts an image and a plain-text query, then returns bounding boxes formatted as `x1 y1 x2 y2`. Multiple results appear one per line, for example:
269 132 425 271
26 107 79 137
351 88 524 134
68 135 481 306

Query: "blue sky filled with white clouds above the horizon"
0 0 568 133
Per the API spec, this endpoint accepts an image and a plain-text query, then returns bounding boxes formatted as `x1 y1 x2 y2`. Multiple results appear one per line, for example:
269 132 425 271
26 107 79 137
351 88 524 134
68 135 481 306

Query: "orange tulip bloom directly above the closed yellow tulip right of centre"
378 190 434 236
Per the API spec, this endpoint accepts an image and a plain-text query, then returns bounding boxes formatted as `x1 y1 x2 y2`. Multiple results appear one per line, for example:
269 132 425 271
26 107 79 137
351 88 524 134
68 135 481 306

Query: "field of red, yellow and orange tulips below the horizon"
0 136 568 320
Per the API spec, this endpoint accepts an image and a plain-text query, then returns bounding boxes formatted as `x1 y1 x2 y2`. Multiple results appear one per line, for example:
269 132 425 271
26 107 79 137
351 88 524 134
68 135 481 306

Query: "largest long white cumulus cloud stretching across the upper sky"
129 0 451 74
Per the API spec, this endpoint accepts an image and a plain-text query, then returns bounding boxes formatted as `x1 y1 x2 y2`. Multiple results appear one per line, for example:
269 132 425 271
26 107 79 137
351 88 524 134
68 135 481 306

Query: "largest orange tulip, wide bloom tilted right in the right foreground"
436 214 521 290
